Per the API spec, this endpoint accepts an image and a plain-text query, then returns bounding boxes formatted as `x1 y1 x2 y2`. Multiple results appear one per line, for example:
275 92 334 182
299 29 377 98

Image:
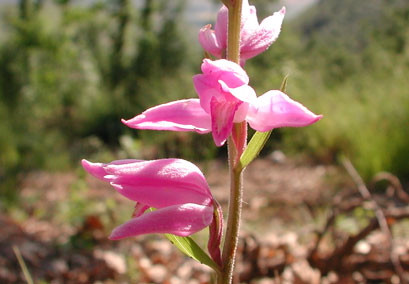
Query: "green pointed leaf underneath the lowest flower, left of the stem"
165 234 220 273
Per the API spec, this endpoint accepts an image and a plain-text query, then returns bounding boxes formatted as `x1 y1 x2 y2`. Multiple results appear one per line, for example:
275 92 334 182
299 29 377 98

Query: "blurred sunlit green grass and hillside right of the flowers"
248 0 409 178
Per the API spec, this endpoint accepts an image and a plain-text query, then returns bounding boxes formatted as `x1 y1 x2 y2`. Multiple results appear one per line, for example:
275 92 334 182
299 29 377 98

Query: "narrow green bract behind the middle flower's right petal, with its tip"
239 75 288 170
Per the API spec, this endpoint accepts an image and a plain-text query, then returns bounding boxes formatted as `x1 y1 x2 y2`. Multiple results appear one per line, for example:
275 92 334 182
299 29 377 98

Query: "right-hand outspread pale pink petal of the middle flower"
247 90 322 131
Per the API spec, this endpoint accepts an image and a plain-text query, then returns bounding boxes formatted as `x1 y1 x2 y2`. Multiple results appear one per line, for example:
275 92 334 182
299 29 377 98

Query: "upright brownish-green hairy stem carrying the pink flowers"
218 0 242 284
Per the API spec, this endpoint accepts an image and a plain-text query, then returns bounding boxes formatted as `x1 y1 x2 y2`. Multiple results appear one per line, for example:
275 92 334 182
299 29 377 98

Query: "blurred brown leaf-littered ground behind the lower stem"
0 156 409 284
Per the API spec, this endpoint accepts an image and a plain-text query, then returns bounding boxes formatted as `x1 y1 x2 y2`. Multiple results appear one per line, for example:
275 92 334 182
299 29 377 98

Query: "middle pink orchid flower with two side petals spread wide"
122 59 322 146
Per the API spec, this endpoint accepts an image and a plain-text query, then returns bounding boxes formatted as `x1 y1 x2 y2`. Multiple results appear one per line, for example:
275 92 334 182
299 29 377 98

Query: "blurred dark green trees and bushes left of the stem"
0 0 207 203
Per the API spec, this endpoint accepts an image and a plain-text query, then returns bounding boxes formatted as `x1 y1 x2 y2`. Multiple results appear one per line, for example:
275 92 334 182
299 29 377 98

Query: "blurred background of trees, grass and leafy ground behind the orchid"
0 0 409 283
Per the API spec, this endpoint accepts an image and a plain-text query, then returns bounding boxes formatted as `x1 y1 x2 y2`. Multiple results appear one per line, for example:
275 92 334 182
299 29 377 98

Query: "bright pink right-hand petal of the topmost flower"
240 7 285 60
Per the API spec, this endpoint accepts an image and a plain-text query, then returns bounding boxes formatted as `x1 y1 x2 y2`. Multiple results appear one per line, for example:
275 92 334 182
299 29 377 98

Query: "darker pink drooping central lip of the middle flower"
210 97 242 147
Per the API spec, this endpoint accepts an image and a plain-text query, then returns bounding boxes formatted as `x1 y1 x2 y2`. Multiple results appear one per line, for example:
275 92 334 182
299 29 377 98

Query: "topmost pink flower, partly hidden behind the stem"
199 0 285 66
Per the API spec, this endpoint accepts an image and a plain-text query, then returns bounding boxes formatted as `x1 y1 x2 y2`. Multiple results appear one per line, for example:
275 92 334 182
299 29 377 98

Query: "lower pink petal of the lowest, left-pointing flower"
109 203 213 240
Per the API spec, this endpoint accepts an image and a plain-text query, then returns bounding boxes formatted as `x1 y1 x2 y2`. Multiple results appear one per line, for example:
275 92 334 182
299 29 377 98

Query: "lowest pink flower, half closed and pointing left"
82 159 213 240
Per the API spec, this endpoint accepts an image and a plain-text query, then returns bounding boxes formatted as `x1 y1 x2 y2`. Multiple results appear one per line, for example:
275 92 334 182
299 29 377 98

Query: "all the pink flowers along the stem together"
82 0 321 245
